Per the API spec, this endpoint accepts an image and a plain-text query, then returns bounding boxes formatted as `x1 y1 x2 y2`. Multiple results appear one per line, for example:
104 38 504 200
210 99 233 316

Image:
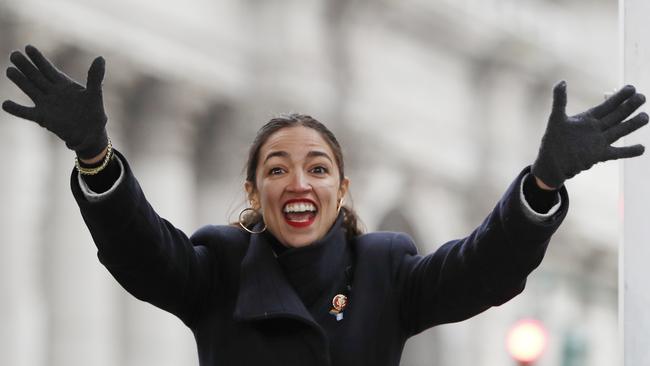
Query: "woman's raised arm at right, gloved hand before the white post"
393 82 648 333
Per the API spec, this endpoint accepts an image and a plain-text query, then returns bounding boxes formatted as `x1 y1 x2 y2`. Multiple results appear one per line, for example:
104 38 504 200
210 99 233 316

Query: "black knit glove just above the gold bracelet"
2 46 108 159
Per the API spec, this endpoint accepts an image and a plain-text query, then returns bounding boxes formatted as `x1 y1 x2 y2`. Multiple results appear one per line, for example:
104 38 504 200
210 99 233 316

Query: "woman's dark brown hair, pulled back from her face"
241 113 363 238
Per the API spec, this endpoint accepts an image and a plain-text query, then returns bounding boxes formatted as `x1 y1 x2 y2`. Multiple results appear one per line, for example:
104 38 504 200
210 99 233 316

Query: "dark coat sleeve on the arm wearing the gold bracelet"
71 152 216 324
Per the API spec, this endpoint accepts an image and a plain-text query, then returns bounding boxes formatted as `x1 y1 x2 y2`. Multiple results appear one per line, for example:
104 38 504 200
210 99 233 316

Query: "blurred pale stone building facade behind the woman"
0 0 621 366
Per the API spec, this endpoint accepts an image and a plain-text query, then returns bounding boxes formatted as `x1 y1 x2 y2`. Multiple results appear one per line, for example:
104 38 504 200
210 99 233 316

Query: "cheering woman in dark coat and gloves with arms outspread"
3 46 648 365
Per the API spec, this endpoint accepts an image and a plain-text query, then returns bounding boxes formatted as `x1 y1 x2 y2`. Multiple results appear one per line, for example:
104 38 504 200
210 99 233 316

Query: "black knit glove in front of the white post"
532 81 648 188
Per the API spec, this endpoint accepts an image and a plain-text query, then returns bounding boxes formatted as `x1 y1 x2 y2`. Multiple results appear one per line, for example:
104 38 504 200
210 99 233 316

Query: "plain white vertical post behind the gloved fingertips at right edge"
619 0 650 366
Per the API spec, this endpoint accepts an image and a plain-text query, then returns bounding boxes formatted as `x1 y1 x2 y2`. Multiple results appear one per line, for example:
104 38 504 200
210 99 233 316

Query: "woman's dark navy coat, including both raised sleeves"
71 155 568 366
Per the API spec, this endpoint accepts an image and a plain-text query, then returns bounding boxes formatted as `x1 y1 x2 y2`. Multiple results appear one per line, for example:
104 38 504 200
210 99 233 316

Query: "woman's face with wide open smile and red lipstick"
245 126 349 247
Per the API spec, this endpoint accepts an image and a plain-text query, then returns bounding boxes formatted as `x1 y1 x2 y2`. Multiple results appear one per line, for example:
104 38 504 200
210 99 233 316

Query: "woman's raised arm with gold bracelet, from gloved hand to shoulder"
2 46 214 322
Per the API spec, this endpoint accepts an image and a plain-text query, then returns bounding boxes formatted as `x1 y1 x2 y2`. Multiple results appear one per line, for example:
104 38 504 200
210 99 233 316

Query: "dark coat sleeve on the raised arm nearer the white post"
391 168 569 335
